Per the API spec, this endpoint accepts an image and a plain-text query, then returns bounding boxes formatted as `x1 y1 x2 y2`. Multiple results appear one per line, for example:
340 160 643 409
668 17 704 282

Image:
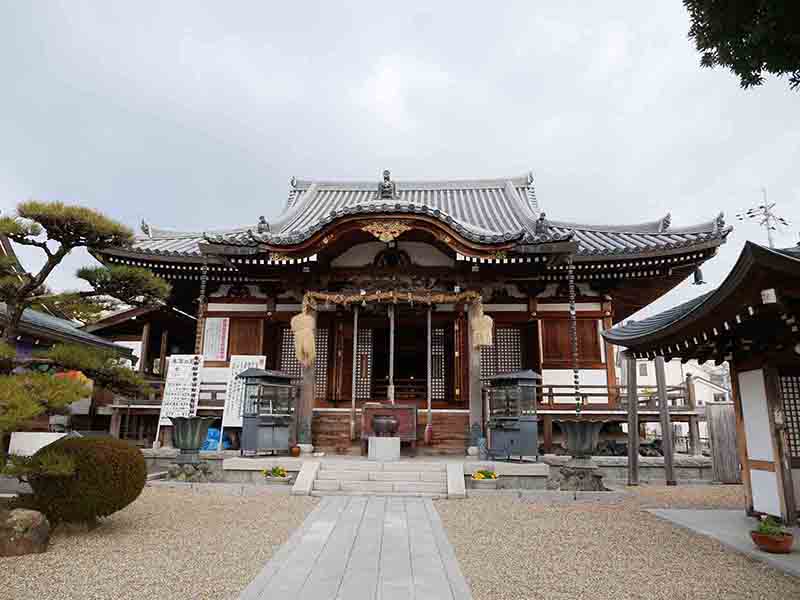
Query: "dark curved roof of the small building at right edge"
603 242 800 349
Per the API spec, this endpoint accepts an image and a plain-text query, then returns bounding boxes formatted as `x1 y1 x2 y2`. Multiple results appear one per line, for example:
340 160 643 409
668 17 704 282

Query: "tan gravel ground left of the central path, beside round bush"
0 487 317 600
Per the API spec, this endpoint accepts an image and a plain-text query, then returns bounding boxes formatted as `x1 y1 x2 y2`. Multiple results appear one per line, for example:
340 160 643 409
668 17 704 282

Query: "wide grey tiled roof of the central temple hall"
130 176 730 257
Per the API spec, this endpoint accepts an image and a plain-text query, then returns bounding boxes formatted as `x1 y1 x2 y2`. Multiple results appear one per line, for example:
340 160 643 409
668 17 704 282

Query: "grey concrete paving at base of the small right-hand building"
650 509 800 577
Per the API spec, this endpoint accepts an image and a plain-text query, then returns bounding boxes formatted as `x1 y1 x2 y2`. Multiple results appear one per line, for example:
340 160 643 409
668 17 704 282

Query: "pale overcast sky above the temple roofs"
0 0 800 318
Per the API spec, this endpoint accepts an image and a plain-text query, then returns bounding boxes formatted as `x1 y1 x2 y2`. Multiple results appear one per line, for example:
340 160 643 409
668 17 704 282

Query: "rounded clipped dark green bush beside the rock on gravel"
28 437 147 524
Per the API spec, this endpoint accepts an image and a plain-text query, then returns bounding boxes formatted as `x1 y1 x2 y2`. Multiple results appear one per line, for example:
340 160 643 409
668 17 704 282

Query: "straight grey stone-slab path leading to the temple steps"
240 496 471 600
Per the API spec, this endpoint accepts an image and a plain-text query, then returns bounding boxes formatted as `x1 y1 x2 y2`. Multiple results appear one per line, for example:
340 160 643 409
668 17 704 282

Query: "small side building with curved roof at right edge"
603 242 800 522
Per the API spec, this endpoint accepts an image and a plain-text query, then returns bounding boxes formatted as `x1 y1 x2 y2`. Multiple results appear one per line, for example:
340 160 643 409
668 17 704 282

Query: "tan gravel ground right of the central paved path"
436 486 800 600
